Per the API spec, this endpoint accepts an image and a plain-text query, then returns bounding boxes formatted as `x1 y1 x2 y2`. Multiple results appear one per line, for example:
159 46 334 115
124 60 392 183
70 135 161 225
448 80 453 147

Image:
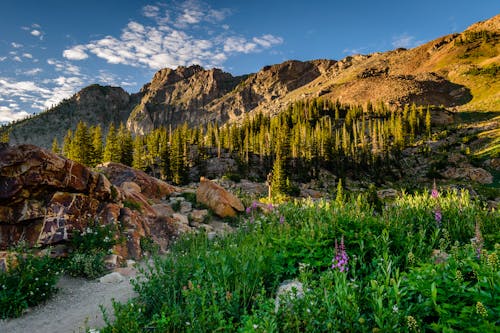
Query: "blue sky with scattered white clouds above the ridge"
0 0 500 123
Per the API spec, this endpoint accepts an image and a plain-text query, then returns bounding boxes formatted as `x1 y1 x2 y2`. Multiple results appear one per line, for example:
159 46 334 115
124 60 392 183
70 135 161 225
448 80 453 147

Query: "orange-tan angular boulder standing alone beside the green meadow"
196 177 245 217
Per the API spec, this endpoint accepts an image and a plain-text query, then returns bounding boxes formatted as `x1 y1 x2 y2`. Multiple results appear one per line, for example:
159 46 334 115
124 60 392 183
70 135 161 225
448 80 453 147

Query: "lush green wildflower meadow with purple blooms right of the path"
101 190 500 332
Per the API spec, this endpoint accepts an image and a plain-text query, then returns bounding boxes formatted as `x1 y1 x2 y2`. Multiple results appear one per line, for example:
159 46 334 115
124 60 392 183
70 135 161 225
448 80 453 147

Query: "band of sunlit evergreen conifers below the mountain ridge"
53 98 431 191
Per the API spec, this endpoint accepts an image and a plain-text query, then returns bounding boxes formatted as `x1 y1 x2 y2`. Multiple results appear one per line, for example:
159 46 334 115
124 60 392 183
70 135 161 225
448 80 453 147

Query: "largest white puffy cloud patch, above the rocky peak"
63 0 283 70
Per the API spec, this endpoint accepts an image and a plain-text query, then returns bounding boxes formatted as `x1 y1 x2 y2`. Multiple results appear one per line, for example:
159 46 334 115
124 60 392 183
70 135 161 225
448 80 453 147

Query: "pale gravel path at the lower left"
0 269 136 333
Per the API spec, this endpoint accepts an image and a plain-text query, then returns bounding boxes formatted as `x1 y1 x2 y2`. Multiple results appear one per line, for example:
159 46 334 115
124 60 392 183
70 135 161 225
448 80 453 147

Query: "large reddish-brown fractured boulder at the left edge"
0 144 117 248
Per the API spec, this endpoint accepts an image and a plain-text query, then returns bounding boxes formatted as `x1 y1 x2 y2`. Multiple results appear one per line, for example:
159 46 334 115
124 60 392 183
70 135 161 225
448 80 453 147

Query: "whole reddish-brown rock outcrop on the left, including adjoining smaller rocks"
0 144 175 259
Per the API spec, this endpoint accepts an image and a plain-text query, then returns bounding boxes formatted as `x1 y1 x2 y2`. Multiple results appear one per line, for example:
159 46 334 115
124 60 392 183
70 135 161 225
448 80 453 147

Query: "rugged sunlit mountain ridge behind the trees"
0 15 500 147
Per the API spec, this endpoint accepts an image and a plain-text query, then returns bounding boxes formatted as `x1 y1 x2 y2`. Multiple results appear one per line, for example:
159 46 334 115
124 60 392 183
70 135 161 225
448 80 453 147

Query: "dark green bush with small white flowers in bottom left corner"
0 253 60 319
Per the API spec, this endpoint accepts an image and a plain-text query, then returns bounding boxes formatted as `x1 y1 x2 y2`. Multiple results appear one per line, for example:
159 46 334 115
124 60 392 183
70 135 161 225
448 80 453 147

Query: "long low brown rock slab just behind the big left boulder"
97 162 179 199
